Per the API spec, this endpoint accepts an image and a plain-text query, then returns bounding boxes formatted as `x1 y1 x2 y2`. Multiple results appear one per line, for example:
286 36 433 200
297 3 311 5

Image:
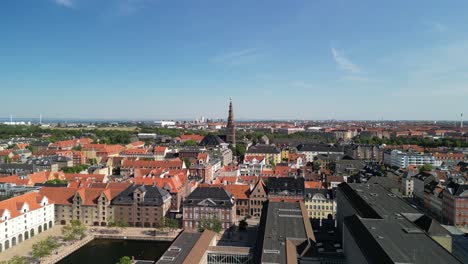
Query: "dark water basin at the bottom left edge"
58 239 171 264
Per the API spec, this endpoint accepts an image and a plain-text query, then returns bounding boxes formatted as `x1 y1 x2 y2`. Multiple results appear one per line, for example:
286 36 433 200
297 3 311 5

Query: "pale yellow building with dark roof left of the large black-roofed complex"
304 188 336 219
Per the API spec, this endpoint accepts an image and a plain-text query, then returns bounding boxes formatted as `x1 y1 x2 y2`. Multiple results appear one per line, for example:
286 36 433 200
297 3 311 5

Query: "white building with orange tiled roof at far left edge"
0 191 55 252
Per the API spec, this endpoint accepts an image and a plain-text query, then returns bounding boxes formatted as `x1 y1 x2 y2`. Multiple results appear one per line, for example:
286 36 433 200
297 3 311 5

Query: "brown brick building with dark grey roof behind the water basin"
112 185 171 227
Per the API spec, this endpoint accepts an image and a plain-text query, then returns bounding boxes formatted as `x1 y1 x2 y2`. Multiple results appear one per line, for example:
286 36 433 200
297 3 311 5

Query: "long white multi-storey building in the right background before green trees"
390 150 441 168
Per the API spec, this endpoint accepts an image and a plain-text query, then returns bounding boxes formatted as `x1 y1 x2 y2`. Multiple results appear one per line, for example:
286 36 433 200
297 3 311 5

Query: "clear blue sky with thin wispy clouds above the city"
0 0 468 120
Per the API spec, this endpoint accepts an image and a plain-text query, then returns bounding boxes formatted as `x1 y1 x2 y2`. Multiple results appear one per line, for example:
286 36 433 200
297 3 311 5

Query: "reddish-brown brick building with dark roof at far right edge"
442 183 468 226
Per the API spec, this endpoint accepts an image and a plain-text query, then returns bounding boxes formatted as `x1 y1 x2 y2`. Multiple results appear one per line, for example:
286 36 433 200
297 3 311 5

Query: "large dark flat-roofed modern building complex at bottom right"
336 183 461 264
